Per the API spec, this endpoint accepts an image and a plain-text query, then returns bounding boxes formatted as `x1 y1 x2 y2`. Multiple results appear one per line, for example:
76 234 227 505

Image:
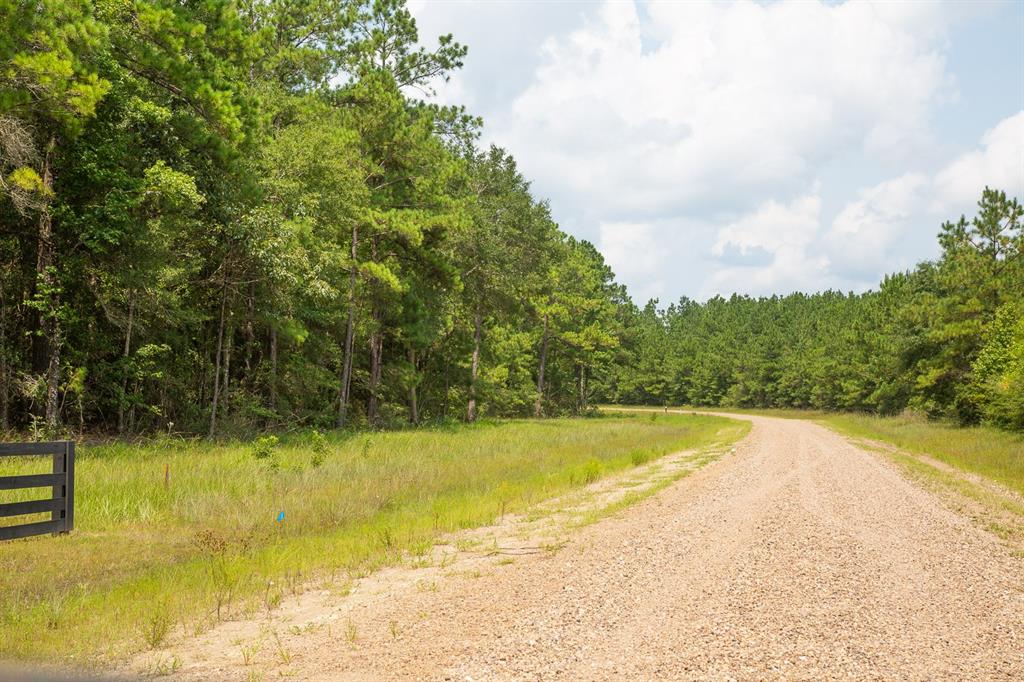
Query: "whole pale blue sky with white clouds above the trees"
409 0 1024 305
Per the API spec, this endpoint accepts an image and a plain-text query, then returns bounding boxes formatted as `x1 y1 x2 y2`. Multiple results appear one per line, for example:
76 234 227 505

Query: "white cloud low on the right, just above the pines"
703 112 1024 295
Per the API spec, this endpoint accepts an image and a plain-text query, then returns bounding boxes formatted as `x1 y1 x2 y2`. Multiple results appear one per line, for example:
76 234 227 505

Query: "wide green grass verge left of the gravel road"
0 415 746 666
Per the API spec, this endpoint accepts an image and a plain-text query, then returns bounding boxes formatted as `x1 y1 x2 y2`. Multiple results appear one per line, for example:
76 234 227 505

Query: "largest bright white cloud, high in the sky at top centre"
493 2 952 219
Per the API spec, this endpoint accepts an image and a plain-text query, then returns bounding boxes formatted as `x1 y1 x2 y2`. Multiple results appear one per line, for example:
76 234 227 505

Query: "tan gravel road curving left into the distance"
161 417 1024 680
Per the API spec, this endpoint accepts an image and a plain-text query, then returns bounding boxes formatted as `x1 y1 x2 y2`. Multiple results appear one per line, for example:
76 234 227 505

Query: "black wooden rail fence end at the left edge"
0 440 75 540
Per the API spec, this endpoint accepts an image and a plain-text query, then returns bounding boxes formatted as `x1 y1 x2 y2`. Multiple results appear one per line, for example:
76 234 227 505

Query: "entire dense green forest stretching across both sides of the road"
0 0 1024 435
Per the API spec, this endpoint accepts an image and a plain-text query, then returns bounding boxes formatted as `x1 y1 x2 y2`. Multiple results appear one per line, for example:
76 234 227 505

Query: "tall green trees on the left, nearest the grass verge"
0 0 628 436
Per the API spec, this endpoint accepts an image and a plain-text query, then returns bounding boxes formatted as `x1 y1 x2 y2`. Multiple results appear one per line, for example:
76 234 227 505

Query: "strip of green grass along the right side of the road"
819 415 1024 495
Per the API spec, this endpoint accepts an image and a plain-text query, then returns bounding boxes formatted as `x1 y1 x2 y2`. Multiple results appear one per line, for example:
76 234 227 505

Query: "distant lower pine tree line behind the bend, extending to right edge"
602 188 1024 430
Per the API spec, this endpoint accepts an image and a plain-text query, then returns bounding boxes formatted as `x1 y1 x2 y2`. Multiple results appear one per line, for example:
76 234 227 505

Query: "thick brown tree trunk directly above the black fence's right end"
36 137 60 433
